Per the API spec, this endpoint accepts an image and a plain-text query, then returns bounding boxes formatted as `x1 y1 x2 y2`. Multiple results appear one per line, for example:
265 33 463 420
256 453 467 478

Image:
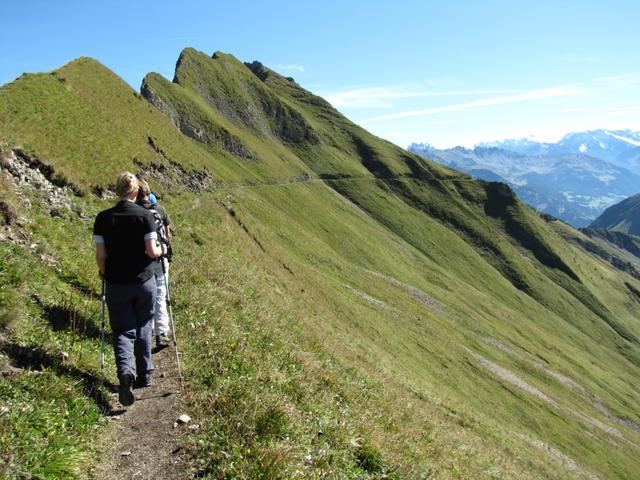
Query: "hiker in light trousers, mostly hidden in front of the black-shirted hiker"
137 175 172 350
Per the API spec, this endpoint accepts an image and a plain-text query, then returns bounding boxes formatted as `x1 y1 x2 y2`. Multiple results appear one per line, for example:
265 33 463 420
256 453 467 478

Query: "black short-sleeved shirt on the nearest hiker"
93 201 157 283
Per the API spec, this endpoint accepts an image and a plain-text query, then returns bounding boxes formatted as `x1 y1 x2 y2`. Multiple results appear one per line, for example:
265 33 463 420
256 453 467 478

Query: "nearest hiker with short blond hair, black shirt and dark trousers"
93 172 167 406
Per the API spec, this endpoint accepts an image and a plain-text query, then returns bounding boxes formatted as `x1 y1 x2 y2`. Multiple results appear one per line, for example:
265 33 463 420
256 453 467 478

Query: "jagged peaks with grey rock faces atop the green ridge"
141 48 319 155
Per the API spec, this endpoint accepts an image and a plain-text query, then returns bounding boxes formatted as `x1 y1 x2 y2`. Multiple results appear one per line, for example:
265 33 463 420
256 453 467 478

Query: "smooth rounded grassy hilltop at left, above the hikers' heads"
0 57 240 186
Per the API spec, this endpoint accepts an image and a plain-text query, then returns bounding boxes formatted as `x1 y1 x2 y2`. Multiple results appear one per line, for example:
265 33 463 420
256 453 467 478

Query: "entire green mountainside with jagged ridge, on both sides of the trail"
0 49 640 479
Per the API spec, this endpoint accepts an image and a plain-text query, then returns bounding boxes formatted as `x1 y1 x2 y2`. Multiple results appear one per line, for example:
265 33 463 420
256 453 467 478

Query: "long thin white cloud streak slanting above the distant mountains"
360 85 589 124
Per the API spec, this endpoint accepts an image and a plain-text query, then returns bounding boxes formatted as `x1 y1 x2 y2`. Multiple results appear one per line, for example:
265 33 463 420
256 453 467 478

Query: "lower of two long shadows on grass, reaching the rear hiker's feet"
0 336 118 415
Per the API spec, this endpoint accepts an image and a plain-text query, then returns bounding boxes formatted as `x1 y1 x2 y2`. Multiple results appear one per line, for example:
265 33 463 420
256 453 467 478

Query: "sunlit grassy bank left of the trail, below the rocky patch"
0 163 108 478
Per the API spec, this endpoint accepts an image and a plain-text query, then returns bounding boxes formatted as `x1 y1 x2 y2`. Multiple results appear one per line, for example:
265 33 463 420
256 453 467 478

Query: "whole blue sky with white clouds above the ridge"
0 0 640 147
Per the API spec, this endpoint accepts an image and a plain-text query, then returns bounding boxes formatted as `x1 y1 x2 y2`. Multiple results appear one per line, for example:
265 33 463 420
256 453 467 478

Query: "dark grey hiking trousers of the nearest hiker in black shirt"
106 277 156 377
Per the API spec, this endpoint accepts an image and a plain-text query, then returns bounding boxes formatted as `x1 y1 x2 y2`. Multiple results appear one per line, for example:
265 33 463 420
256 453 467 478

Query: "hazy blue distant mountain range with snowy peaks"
409 130 640 227
